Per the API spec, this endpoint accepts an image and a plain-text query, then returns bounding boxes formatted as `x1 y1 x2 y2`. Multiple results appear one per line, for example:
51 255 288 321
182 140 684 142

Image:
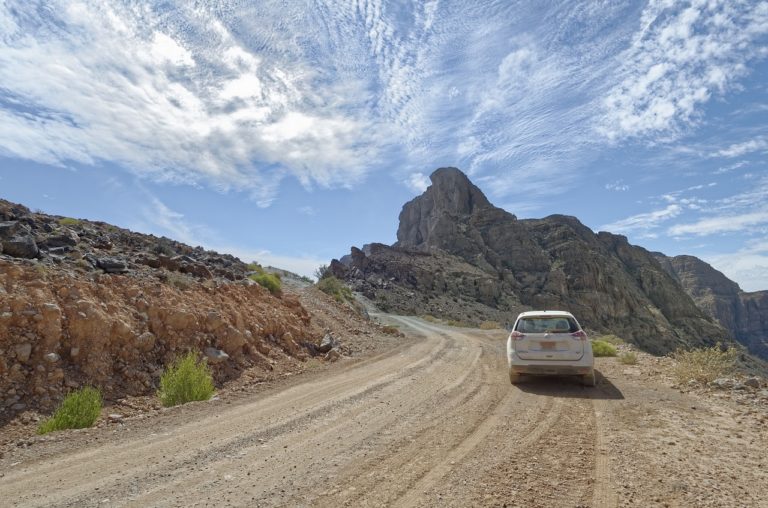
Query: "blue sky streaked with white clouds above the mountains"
0 0 768 290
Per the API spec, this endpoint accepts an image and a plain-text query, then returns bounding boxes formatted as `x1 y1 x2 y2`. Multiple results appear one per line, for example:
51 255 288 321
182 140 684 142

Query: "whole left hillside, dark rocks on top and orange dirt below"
0 200 380 424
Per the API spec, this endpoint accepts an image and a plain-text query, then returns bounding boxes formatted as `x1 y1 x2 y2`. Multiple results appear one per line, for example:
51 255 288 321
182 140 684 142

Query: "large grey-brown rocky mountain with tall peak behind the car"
331 168 728 353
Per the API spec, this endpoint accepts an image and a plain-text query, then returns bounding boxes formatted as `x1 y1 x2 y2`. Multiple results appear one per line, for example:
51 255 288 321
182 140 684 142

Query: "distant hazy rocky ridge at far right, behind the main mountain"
654 252 768 359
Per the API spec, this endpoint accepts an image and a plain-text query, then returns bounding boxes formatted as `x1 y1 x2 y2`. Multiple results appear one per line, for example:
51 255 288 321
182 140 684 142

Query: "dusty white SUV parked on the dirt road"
507 310 595 386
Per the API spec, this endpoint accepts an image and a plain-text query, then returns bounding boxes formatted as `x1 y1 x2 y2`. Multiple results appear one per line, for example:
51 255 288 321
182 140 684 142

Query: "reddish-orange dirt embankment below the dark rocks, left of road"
0 260 322 419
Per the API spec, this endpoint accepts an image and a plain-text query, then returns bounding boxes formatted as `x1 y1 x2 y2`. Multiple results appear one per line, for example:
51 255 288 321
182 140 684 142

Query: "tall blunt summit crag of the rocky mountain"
397 167 495 248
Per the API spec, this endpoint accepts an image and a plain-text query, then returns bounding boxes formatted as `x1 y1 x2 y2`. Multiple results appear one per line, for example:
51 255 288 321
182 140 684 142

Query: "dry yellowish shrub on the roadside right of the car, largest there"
671 343 739 384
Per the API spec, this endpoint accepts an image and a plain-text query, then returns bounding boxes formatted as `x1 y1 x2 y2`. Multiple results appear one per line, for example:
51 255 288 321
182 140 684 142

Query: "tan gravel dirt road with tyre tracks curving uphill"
0 317 768 507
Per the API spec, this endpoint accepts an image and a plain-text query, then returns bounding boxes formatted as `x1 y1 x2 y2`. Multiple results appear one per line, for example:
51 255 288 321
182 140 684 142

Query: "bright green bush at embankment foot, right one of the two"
157 352 214 407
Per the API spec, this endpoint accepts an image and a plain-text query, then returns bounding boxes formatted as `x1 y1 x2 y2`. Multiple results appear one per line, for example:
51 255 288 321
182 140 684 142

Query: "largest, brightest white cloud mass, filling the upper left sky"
0 0 384 204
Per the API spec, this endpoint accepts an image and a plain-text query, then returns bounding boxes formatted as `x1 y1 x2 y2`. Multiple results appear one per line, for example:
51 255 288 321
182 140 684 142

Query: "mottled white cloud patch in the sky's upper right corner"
599 0 768 140
